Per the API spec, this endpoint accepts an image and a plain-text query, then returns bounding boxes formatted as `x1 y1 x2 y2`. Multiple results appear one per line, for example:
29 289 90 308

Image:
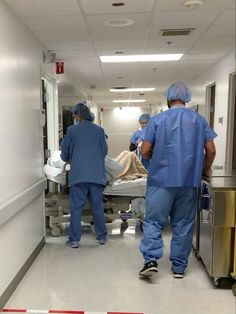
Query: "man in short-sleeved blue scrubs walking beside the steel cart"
139 82 216 278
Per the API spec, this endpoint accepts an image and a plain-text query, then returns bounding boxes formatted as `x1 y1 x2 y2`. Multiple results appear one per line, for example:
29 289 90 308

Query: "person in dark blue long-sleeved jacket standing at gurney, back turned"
61 103 108 248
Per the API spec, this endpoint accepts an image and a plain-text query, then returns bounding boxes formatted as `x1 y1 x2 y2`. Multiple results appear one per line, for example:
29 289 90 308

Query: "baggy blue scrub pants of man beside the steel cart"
139 186 197 273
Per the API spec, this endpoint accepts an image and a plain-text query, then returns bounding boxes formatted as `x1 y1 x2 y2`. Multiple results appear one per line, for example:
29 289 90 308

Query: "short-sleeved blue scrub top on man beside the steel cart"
144 105 217 187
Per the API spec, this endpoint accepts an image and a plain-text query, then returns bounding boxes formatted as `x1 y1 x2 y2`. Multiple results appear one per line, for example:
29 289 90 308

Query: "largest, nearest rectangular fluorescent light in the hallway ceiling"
100 53 183 62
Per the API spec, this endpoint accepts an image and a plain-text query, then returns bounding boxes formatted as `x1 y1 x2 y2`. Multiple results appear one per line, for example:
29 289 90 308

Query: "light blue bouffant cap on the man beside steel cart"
164 82 191 103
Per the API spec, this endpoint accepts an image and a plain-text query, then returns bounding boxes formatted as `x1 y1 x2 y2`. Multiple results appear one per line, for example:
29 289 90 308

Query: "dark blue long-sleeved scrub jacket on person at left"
61 120 108 186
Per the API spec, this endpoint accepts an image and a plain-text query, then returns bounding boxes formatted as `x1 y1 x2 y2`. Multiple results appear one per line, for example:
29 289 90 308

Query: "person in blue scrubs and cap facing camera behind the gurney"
129 113 150 170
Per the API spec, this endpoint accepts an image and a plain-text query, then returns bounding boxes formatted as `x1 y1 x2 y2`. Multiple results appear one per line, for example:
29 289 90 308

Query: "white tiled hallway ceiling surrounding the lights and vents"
5 0 235 106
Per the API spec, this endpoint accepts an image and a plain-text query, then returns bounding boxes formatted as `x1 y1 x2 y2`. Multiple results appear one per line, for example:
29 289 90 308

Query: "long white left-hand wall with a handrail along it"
0 1 51 299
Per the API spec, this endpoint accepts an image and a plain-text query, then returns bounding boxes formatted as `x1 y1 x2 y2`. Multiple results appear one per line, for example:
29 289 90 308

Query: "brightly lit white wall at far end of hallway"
101 107 149 157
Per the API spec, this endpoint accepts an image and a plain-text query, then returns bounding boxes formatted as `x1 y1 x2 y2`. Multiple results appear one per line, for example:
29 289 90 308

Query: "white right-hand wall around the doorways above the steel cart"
189 51 235 167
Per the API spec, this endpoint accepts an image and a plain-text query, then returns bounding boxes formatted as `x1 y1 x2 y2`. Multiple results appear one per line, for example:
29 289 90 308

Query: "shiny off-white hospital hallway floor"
5 219 236 314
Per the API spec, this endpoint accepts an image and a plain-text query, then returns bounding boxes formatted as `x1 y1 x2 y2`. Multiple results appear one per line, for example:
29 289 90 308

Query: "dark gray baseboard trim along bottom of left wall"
0 237 45 311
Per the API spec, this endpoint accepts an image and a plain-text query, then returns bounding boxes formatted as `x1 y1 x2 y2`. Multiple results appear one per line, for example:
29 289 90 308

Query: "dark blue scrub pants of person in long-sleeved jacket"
69 183 107 242
